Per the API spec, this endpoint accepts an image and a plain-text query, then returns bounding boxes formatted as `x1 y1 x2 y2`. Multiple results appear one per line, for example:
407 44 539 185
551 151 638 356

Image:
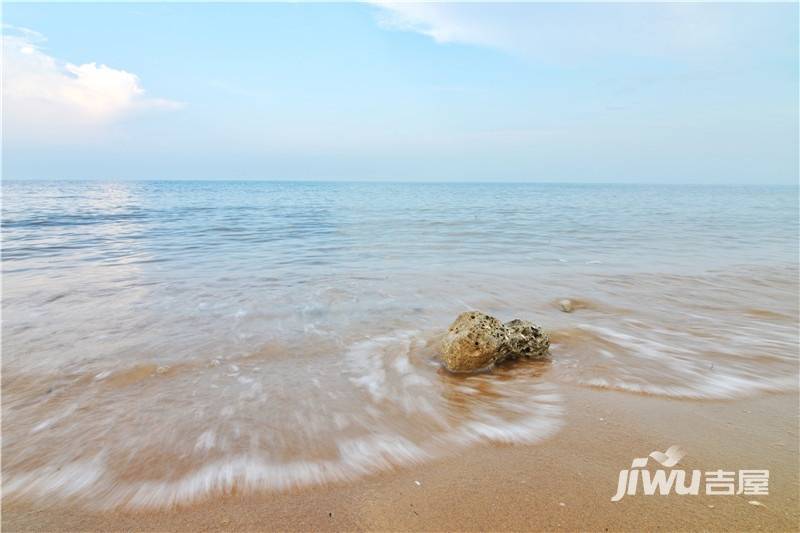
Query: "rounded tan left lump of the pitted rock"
441 311 508 372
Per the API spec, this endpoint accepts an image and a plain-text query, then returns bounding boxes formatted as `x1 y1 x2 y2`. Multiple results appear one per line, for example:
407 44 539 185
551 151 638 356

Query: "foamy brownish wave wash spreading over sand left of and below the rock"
4 331 563 509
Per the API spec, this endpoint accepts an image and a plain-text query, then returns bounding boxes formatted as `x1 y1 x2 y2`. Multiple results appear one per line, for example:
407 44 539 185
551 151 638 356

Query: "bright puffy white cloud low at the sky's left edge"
2 26 182 140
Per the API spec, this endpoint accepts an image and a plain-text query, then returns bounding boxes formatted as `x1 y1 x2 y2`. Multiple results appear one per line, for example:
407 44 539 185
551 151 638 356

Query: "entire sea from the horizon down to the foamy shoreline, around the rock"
2 182 798 507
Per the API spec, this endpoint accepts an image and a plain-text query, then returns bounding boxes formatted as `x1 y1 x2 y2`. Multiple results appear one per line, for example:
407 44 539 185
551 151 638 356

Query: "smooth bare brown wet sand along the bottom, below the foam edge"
2 387 800 531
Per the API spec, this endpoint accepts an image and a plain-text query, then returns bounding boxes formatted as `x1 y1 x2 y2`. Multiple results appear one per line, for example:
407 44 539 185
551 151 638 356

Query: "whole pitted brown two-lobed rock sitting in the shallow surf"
441 311 550 372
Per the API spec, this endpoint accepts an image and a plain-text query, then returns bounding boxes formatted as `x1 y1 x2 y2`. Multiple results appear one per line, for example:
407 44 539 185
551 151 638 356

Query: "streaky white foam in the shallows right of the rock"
552 320 797 399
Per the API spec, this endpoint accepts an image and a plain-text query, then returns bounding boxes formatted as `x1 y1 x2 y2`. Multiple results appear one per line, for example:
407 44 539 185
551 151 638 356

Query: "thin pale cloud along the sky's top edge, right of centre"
371 1 764 62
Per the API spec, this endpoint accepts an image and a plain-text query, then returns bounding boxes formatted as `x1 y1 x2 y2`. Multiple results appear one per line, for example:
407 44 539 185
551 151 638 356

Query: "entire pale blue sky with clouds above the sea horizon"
2 3 800 184
